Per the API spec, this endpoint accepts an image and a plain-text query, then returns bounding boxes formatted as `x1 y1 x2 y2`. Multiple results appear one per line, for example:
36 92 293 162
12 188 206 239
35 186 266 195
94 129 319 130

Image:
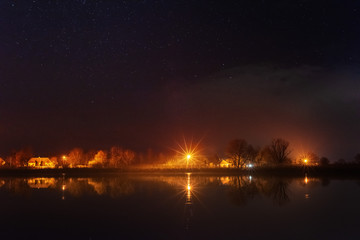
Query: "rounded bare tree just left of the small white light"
226 139 248 168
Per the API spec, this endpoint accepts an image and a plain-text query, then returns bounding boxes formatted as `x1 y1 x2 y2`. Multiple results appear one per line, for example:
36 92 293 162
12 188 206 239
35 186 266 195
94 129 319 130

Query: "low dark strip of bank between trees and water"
0 165 360 178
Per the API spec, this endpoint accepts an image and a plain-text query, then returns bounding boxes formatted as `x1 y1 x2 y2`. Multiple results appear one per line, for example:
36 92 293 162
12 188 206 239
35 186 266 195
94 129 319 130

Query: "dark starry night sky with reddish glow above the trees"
0 0 360 161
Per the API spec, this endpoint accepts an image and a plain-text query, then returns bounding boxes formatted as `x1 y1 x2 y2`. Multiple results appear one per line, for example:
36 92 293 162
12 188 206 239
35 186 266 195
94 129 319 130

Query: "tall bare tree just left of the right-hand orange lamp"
268 138 291 164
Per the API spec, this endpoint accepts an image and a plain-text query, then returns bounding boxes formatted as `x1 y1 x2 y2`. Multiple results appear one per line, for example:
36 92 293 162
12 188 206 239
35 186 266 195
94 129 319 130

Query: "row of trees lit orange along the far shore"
0 138 360 168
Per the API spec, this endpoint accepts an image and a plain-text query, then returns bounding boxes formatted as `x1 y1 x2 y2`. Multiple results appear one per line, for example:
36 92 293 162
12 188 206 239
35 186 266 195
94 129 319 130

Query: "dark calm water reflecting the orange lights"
0 174 360 239
